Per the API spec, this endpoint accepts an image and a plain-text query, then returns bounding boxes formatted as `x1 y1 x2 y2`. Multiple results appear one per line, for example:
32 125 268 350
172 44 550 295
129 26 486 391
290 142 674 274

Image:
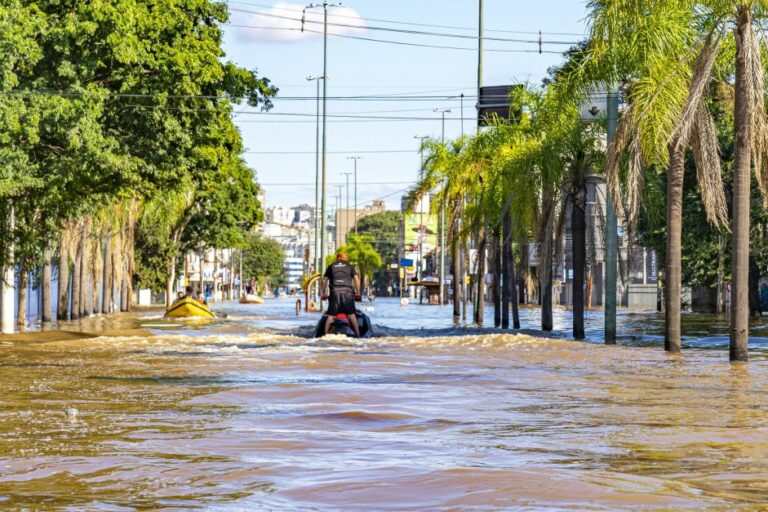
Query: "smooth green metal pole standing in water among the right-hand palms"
605 84 619 345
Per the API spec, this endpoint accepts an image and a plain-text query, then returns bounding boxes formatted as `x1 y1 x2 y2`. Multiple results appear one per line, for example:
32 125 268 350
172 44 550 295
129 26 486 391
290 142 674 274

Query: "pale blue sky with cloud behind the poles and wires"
219 0 587 208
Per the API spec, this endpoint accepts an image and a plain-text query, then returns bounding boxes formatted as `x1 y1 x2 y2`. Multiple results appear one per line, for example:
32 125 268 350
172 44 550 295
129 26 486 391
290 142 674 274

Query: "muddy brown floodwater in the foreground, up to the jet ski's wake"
0 300 768 511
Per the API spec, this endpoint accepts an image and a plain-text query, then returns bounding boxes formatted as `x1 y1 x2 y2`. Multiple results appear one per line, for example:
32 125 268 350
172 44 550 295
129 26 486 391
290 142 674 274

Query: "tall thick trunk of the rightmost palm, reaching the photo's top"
730 9 762 361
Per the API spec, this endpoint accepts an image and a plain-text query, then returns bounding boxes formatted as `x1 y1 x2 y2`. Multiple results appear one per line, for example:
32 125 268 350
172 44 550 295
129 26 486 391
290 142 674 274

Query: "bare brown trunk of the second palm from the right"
664 141 685 352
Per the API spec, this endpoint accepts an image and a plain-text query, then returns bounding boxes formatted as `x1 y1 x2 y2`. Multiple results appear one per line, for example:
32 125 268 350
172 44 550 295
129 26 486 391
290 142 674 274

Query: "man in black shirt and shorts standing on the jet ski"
320 251 360 337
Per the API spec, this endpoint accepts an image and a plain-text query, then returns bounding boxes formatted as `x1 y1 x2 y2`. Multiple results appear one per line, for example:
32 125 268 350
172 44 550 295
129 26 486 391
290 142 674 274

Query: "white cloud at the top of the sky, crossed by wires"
233 2 366 43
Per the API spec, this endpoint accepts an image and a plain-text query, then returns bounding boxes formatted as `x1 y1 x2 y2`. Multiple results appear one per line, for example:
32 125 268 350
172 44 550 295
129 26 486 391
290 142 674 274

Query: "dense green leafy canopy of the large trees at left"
0 0 277 280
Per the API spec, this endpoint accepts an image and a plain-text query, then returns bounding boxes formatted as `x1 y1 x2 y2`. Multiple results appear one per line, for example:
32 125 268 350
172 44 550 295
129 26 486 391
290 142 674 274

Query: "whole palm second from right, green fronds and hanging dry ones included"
573 0 738 352
